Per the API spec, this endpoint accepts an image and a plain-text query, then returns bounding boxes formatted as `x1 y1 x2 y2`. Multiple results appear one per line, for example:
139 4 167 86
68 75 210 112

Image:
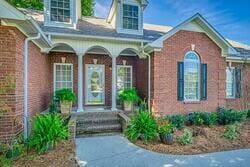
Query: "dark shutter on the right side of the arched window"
200 64 207 100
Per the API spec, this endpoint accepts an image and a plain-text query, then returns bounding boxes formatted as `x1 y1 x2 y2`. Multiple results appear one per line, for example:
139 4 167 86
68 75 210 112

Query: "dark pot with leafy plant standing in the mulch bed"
158 122 174 144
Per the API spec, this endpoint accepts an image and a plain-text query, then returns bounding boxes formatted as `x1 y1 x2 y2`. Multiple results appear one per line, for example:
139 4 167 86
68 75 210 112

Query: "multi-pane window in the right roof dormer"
123 4 139 30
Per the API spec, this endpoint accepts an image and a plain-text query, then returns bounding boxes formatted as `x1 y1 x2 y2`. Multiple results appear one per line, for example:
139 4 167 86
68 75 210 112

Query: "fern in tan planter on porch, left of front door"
56 89 76 114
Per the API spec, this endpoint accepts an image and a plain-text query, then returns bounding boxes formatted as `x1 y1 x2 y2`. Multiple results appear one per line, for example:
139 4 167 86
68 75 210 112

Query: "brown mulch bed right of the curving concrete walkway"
134 119 250 155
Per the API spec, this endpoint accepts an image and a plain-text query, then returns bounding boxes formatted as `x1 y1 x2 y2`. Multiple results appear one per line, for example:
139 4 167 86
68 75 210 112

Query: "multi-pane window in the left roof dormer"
50 0 70 23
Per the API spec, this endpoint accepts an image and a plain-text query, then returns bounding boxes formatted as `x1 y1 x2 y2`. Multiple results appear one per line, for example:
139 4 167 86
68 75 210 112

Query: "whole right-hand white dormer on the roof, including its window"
107 0 148 35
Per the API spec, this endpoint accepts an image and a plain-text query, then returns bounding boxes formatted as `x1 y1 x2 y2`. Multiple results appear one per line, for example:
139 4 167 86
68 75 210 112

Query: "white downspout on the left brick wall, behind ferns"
23 33 41 141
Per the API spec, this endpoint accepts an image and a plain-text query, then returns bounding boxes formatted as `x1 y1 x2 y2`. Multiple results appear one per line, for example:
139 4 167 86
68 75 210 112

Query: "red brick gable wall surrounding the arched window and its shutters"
152 31 226 114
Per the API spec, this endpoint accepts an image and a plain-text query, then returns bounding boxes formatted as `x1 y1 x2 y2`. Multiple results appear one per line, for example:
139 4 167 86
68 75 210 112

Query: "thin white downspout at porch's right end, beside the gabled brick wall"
141 42 151 112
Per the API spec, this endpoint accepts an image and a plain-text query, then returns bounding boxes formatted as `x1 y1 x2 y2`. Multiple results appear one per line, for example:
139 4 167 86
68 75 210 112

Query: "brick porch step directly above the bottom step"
76 116 120 126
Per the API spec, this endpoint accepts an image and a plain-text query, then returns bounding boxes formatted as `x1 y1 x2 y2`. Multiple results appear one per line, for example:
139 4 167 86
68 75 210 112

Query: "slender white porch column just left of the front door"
77 54 83 112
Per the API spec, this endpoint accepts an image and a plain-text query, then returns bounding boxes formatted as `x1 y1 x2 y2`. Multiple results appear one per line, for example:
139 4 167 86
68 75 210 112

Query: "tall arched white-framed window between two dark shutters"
184 52 200 101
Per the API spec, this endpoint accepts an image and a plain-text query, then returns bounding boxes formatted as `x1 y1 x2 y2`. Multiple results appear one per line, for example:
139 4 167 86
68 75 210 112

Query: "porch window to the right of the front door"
117 66 132 93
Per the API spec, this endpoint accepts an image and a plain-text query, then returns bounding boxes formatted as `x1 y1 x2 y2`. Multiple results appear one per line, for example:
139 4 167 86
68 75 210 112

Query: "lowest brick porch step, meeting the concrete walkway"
76 124 122 136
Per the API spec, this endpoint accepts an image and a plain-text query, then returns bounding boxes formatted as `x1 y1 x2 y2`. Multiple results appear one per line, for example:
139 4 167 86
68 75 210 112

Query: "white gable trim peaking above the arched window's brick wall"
147 13 239 55
